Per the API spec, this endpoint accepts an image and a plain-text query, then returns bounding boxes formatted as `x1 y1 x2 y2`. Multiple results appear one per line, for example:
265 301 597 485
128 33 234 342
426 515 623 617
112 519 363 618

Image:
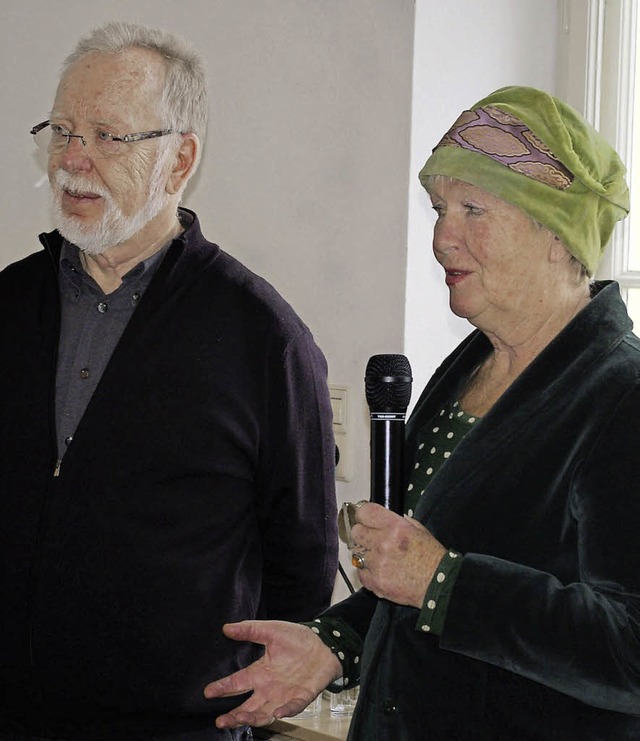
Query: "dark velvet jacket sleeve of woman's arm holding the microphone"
440 388 640 714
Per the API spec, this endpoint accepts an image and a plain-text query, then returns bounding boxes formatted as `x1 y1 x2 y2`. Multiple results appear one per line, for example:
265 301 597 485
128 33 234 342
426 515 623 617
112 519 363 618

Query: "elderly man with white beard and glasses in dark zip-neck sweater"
0 23 337 741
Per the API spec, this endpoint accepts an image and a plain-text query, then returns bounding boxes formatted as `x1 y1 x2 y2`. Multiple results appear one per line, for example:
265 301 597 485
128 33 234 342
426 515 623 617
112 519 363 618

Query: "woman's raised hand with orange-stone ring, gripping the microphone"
351 502 447 609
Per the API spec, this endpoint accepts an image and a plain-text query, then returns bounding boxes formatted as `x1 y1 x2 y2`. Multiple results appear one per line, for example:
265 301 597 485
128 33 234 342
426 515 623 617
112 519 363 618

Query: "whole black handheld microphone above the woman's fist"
364 355 413 514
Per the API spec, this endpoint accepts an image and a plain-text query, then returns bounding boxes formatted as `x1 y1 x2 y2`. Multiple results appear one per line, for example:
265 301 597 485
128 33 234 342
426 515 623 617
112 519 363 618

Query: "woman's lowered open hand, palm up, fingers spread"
204 620 342 728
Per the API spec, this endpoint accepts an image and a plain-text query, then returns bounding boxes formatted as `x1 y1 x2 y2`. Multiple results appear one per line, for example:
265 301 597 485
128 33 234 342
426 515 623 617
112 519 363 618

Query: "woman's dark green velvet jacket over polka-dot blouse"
329 283 640 741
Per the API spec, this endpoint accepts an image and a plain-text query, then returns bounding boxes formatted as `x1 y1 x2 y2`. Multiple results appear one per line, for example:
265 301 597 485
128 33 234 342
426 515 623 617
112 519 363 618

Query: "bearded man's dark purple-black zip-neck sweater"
0 210 337 741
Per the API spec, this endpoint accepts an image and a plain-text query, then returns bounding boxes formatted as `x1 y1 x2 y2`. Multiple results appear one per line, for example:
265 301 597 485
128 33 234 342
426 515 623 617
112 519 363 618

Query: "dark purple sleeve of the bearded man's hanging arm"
258 331 338 621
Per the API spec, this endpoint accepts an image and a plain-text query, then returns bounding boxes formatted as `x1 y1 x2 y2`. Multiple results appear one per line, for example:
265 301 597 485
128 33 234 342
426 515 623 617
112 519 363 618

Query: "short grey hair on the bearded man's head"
61 22 208 144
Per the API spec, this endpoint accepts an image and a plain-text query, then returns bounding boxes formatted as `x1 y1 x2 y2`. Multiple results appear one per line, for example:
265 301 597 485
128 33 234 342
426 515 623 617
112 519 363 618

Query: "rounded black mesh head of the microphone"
364 355 413 413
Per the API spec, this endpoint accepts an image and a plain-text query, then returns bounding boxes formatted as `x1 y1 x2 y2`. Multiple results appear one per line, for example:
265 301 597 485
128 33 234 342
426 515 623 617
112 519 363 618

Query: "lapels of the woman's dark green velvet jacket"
406 282 632 524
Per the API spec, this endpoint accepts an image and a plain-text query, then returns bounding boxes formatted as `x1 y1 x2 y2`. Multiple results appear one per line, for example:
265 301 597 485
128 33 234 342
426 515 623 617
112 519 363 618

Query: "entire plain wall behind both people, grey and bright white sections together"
0 0 557 600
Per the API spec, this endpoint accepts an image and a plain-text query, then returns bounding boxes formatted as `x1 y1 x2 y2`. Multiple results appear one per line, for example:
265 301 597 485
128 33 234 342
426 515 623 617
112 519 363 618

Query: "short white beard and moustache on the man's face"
51 155 170 255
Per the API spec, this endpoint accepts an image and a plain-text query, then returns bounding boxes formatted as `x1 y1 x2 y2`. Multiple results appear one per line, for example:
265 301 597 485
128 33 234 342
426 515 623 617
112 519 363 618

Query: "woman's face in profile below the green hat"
429 178 557 334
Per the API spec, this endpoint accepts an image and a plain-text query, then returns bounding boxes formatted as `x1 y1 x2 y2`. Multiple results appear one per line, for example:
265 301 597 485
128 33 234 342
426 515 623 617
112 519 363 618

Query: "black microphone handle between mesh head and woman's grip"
371 412 405 514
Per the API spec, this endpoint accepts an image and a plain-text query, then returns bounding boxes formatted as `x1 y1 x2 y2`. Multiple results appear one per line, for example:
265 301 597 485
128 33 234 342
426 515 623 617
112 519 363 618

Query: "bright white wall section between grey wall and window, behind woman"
405 0 558 402
